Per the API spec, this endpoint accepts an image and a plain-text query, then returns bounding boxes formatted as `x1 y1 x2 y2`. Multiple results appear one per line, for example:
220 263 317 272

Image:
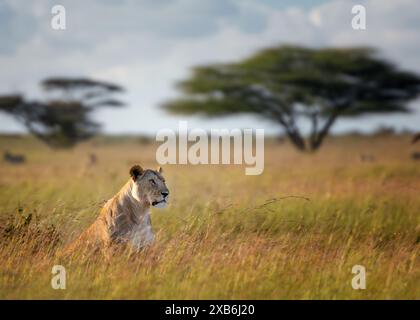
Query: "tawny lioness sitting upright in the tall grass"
65 165 169 253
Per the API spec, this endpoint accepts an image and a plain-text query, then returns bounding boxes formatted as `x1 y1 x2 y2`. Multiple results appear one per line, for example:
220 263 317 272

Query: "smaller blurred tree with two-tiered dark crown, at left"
0 78 123 147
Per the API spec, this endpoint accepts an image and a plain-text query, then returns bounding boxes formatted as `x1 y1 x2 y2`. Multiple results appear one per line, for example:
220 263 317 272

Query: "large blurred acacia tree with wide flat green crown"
163 46 420 151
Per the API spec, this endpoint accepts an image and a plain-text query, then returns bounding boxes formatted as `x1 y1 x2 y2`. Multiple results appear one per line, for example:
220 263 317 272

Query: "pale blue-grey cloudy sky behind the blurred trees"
0 0 420 133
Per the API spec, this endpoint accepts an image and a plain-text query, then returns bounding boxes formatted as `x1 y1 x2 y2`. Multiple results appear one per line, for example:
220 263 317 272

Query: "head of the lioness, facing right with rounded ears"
130 165 169 208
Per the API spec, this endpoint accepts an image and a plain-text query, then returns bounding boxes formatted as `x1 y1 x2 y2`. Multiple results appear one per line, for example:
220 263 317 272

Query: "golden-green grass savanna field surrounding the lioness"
0 135 420 299
